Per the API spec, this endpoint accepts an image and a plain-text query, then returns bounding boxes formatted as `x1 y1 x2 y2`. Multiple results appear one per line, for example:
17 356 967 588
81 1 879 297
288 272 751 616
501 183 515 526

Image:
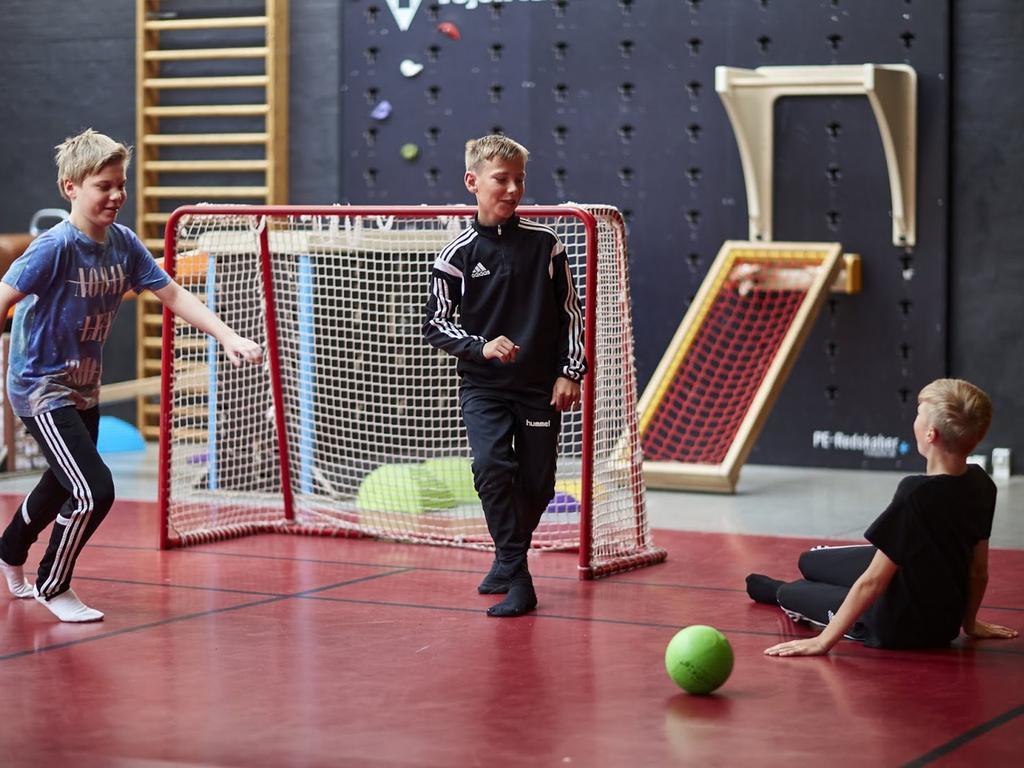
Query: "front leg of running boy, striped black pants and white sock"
24 408 114 622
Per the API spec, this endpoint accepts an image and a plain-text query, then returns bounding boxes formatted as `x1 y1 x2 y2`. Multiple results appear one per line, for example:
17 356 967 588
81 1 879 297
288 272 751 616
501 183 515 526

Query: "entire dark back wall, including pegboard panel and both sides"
0 0 1024 467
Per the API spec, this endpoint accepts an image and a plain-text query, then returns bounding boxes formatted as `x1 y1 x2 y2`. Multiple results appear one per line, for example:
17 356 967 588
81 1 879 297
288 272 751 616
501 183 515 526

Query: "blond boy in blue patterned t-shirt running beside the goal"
0 129 262 622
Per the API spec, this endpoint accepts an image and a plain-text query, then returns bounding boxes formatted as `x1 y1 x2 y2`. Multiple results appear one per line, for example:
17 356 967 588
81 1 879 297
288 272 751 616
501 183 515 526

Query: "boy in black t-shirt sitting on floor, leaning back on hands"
746 379 1017 656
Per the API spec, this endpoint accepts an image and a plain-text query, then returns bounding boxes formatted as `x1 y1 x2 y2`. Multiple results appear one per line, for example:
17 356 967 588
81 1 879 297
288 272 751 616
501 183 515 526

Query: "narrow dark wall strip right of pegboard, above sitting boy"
949 0 1024 472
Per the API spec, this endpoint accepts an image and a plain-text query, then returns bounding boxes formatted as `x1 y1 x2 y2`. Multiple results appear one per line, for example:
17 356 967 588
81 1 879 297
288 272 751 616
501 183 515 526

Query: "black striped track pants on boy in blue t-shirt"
0 407 114 598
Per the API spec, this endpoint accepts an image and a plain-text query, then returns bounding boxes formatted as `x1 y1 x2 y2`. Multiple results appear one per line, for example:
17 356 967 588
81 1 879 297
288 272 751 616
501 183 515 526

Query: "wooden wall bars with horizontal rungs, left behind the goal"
133 0 289 438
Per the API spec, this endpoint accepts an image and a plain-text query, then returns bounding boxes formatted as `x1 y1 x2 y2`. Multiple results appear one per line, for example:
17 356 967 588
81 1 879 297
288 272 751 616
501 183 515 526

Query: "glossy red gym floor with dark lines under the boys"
0 496 1024 768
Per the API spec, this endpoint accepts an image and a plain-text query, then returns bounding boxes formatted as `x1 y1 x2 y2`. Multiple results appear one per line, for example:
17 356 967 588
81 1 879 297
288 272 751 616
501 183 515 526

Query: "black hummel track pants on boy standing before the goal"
459 387 561 568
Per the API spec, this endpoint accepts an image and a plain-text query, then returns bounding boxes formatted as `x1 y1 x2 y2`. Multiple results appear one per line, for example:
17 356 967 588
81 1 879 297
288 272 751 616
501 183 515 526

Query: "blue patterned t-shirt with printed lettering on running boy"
3 220 171 416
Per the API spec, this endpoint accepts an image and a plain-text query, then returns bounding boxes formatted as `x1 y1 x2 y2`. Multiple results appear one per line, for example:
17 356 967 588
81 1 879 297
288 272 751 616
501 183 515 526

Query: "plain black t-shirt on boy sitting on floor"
864 465 995 648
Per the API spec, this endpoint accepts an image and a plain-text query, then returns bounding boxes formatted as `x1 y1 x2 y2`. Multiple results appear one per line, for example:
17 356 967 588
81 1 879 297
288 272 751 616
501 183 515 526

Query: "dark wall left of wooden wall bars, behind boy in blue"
0 0 135 420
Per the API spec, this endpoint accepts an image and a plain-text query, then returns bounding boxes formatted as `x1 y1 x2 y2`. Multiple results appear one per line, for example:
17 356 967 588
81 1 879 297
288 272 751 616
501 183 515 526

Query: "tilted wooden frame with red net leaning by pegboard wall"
641 244 839 489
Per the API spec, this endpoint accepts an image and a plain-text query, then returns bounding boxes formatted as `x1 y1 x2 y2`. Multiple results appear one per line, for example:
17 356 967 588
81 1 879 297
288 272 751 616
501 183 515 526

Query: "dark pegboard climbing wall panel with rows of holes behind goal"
340 0 949 469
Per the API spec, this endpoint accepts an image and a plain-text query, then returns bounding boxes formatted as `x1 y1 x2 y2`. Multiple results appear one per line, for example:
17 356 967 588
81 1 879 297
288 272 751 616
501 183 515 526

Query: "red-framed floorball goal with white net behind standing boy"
160 205 666 579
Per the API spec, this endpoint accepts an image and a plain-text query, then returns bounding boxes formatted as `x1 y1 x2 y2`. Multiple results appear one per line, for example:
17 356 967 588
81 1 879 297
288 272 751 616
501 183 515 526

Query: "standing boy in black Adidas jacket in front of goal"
423 135 587 616
